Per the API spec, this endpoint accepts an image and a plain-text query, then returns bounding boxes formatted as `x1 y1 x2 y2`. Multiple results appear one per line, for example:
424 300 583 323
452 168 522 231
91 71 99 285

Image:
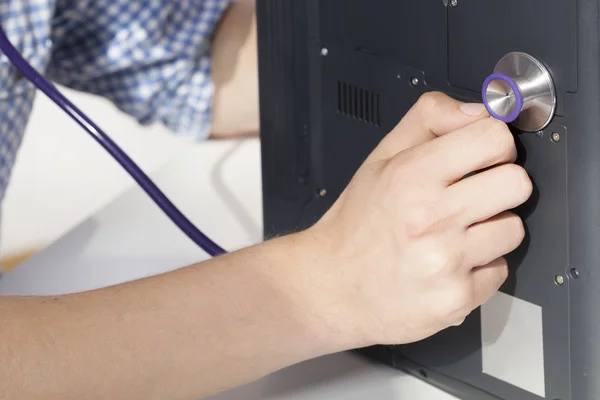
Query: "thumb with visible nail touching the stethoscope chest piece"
367 92 489 162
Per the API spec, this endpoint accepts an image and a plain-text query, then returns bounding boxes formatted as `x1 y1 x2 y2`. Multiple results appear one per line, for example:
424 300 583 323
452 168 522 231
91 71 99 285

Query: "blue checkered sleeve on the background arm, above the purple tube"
47 0 234 139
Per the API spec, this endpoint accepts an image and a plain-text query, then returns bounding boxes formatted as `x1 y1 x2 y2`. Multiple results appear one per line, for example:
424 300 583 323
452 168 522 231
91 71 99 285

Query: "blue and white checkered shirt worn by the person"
0 0 234 200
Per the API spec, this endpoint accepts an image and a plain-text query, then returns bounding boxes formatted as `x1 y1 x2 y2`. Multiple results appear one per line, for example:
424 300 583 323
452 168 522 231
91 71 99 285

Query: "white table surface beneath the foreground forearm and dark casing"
0 139 454 400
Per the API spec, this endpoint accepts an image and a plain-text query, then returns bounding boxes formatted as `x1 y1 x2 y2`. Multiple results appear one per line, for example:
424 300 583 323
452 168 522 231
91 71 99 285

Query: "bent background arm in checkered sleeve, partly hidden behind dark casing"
46 0 258 139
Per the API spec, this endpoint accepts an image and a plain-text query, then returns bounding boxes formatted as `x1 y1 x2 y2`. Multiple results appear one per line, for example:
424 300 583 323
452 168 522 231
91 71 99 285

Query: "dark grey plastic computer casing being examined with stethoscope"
257 0 600 400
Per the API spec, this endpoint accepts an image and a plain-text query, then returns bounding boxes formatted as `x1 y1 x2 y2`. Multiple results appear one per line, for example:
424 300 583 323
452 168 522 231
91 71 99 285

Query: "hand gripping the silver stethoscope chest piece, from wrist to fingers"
307 93 532 346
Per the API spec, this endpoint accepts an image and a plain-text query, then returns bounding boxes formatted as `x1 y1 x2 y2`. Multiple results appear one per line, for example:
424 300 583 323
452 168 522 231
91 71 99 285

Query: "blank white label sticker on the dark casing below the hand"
481 292 546 398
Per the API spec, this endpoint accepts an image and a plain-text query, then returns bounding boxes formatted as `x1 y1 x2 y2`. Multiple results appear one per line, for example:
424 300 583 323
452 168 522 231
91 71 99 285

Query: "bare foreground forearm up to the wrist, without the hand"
0 236 347 400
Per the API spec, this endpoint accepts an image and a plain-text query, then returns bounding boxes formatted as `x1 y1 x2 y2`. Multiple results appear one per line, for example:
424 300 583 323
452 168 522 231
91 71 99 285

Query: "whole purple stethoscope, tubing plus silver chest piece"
0 18 556 257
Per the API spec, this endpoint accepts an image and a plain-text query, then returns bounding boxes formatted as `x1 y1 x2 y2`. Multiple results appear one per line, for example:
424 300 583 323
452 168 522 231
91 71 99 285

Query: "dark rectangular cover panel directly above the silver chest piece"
448 0 577 112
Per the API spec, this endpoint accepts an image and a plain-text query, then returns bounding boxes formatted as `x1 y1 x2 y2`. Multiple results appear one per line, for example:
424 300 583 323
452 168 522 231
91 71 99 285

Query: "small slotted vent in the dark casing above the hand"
337 81 381 127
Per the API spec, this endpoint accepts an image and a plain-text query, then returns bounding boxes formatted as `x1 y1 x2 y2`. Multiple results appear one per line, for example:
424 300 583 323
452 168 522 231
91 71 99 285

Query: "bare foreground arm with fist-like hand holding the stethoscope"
0 95 530 400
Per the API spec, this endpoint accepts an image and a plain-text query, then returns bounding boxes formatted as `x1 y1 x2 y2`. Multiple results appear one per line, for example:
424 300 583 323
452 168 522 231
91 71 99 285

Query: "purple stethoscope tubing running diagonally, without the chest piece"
0 28 226 257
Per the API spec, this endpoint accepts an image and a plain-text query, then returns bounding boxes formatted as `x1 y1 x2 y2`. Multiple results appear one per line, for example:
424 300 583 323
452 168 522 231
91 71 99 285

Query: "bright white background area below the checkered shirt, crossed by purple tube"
0 88 193 258
